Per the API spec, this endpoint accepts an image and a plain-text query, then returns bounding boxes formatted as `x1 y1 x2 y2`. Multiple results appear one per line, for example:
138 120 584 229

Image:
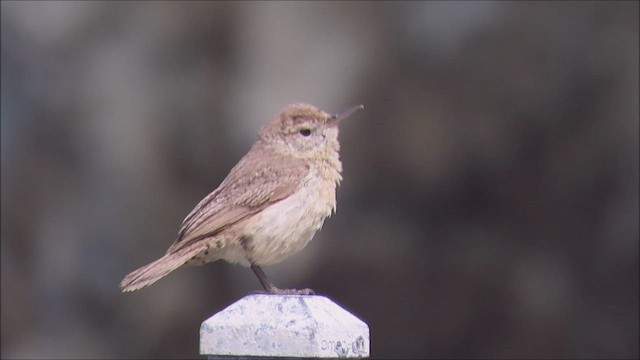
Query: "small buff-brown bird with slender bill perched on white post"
120 104 364 294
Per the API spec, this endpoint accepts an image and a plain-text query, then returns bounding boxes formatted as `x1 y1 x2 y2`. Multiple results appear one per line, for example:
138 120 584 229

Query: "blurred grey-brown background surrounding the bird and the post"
1 1 640 359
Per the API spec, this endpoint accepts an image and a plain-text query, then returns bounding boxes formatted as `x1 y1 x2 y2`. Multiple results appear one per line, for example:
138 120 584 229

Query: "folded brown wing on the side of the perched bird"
167 149 309 253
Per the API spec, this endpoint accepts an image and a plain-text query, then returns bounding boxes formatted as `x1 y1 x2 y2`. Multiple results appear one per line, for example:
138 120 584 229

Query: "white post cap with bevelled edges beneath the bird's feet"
200 294 369 358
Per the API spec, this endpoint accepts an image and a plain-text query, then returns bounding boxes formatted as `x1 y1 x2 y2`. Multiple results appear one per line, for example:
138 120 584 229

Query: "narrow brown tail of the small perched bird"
120 243 202 292
